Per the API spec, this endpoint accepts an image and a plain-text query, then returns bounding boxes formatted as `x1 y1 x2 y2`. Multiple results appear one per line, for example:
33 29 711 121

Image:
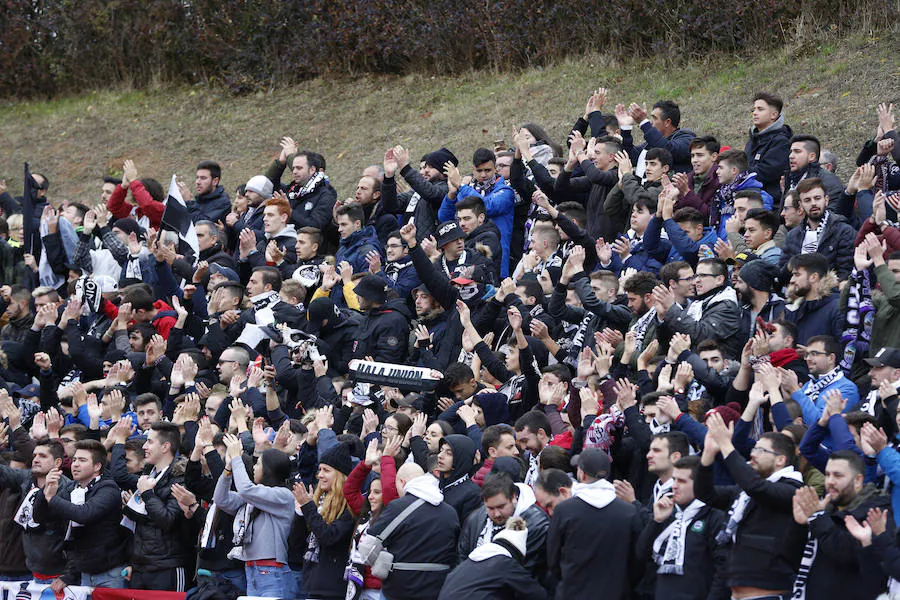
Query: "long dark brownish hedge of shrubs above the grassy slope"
0 0 898 97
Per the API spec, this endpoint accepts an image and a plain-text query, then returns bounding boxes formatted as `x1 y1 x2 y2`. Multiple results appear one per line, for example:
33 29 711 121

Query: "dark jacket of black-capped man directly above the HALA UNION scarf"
352 298 411 364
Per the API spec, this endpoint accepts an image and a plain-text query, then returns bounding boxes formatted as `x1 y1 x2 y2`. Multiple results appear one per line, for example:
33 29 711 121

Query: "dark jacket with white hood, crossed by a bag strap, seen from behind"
369 475 459 600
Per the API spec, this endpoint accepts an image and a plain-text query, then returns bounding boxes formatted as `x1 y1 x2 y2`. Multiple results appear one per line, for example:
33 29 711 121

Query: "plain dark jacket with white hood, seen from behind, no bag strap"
547 479 641 600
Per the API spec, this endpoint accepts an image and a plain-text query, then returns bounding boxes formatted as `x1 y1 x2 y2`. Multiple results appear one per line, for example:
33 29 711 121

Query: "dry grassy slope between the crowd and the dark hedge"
0 34 900 202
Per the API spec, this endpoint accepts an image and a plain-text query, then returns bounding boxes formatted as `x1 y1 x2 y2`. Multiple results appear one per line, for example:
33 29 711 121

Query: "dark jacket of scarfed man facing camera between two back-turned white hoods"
457 483 550 579
